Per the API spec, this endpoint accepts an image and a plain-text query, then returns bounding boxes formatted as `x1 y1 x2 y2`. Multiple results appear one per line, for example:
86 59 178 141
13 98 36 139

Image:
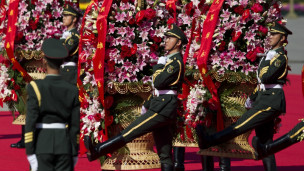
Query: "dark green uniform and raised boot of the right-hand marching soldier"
197 47 288 152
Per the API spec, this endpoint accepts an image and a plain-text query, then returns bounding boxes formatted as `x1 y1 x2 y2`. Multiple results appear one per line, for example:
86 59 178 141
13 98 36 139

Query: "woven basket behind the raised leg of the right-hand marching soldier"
198 82 255 159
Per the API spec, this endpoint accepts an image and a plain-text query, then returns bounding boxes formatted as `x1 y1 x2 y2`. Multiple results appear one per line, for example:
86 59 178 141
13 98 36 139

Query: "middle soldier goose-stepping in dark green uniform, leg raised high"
84 24 187 171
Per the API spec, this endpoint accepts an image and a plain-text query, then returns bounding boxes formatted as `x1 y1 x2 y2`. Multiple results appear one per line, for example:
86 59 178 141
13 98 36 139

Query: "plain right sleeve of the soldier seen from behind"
69 92 80 156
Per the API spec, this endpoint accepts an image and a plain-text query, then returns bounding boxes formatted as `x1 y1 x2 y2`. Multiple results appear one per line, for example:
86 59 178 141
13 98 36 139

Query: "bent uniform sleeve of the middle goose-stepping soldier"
153 59 182 90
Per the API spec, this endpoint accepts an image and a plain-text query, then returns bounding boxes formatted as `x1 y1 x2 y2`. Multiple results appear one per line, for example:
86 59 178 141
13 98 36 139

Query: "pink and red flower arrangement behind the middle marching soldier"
79 0 209 141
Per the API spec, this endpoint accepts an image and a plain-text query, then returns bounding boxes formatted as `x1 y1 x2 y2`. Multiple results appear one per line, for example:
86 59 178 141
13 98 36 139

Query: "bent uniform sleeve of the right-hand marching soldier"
259 54 288 84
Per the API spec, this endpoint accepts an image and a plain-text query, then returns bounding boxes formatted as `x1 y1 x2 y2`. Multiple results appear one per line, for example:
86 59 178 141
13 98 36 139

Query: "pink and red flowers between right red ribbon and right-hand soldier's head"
205 0 281 75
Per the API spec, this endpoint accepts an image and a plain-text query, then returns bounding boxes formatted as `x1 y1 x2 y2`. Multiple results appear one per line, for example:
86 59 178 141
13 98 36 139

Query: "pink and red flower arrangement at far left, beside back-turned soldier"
0 0 78 114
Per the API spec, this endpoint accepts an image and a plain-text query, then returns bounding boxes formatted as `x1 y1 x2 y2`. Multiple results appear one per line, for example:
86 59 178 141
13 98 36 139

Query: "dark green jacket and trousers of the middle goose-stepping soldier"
121 53 184 165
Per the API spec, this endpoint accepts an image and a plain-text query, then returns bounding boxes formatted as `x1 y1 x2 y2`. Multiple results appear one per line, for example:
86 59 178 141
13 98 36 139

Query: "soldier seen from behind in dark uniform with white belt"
25 39 80 171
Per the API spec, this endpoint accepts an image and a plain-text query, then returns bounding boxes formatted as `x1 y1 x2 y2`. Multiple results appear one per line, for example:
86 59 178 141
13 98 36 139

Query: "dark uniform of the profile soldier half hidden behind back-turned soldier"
60 28 79 85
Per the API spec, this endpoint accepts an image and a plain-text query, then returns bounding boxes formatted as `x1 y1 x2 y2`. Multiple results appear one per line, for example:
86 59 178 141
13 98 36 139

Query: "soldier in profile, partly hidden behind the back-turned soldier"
60 4 82 85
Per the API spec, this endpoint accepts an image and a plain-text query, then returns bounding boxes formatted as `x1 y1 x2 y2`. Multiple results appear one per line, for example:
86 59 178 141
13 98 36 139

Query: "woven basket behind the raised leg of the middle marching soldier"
101 93 160 170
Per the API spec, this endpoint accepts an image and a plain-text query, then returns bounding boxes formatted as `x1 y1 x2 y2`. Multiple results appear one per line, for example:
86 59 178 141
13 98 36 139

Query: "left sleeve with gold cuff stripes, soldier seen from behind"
24 84 39 155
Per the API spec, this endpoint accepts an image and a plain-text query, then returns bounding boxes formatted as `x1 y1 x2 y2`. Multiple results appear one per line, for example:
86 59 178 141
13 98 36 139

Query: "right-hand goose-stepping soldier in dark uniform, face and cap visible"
196 22 292 171
